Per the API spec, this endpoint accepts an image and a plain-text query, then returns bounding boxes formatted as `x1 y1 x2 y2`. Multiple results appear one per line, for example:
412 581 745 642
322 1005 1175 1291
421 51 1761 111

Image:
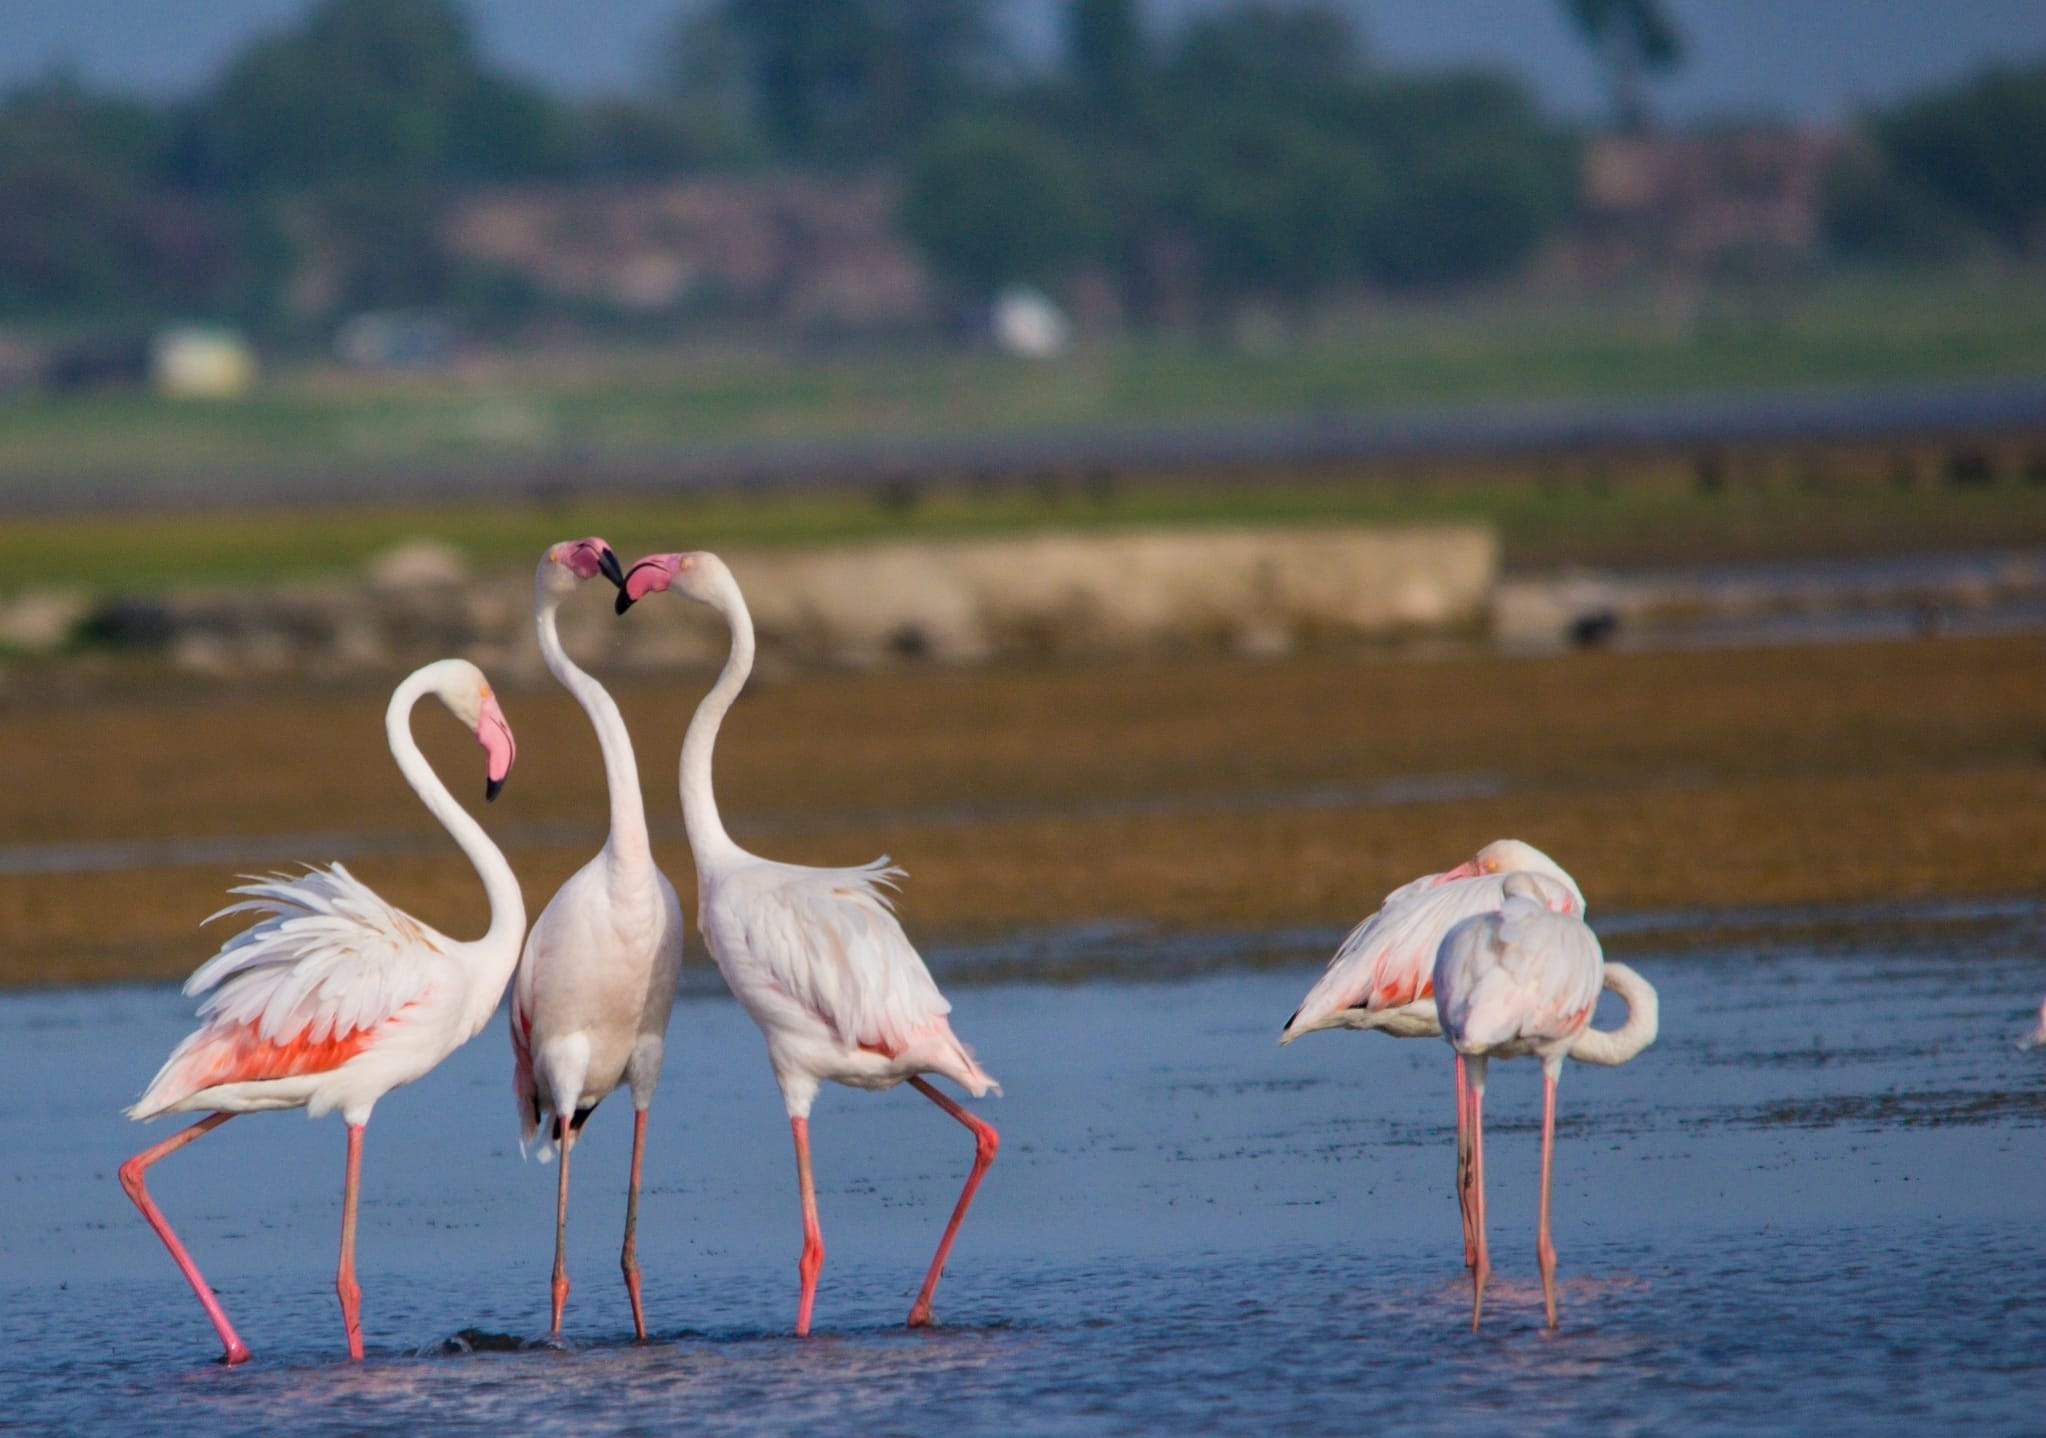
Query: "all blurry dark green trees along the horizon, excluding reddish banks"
0 0 2046 329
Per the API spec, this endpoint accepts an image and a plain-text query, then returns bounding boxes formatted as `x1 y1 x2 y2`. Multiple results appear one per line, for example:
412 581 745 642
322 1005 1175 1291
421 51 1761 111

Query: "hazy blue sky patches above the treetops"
12 0 2046 121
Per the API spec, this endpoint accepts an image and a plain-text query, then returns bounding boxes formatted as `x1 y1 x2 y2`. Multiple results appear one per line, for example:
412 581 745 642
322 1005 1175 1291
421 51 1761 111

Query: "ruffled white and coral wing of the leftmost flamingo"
129 863 452 1117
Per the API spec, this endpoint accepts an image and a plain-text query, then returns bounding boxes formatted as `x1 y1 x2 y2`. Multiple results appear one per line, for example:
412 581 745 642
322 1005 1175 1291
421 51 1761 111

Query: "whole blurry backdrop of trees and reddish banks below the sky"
0 0 2046 372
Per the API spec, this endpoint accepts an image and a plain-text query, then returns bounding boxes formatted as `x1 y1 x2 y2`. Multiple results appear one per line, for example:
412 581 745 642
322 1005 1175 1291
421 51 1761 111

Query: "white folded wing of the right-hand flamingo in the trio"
728 859 951 1055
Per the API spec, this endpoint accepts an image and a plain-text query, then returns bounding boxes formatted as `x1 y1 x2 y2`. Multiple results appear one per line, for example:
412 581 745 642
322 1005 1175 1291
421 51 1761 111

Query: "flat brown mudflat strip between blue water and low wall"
0 636 2046 984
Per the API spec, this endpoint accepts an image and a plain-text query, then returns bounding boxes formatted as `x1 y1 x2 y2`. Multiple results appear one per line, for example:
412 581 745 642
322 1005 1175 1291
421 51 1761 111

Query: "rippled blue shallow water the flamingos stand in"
0 904 2046 1434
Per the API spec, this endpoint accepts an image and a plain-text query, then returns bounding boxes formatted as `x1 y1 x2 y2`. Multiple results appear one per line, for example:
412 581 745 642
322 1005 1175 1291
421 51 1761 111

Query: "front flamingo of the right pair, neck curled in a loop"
1434 873 1657 1332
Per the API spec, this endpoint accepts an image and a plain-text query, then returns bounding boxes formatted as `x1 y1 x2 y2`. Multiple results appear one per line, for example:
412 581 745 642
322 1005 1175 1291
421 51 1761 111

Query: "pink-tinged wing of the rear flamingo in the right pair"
1285 873 1530 1035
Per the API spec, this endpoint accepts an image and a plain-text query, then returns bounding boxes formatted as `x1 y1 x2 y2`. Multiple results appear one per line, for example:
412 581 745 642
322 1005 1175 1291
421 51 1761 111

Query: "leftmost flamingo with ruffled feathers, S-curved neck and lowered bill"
121 659 526 1364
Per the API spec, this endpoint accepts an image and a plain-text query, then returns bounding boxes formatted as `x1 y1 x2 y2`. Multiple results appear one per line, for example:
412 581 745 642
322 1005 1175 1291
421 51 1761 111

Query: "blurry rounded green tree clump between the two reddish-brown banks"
902 0 1575 321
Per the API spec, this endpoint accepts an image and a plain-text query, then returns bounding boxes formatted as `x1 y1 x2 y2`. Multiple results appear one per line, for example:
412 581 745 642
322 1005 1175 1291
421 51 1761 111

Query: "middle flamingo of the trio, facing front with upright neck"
512 536 683 1340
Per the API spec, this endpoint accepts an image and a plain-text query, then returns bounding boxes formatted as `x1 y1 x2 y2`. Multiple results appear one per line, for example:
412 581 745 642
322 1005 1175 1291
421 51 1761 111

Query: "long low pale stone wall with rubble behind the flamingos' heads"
0 526 1498 675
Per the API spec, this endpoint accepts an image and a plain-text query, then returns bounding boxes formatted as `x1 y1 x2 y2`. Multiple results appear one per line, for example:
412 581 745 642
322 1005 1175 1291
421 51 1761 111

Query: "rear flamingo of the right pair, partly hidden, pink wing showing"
1279 839 1584 1268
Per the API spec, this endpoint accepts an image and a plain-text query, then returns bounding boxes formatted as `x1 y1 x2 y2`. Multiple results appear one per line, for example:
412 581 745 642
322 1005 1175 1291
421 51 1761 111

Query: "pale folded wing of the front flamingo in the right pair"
1434 900 1604 1051
